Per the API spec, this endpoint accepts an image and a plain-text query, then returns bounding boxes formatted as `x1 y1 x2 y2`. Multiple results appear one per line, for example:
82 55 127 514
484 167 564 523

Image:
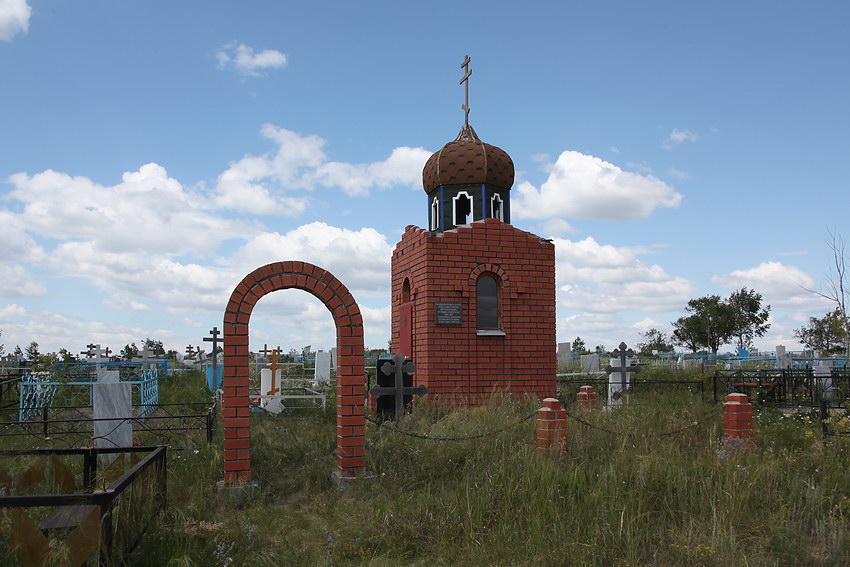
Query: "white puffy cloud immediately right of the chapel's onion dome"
512 151 682 220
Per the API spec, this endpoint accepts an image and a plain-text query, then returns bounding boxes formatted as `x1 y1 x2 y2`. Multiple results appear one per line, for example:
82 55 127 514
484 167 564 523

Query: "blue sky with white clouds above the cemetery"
0 0 850 358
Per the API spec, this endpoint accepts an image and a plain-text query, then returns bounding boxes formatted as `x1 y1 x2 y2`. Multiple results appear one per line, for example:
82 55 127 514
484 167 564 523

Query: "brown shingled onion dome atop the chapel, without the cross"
422 124 514 194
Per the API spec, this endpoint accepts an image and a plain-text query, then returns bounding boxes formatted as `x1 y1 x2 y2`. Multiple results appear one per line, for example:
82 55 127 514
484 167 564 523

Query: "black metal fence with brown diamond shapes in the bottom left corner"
0 446 167 567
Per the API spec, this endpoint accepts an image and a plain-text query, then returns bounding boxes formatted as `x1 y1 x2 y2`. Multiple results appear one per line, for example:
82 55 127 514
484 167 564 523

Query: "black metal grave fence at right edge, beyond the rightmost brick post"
713 367 850 407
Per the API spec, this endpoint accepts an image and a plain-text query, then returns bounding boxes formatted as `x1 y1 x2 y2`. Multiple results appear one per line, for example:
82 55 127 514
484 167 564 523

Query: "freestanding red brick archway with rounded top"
222 262 366 483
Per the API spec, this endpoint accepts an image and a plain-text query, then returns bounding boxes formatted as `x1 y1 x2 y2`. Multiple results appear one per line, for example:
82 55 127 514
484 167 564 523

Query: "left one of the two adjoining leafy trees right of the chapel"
673 295 737 356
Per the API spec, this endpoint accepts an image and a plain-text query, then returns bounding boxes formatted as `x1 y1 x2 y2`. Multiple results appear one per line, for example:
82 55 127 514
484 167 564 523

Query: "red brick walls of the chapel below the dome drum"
392 219 556 403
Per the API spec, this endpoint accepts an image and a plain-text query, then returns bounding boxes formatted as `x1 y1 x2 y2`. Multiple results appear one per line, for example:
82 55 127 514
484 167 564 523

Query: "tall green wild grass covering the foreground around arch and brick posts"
127 376 850 566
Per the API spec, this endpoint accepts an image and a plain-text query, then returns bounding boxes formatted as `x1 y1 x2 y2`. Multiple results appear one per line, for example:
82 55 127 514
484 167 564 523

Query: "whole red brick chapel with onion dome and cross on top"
392 58 556 404
